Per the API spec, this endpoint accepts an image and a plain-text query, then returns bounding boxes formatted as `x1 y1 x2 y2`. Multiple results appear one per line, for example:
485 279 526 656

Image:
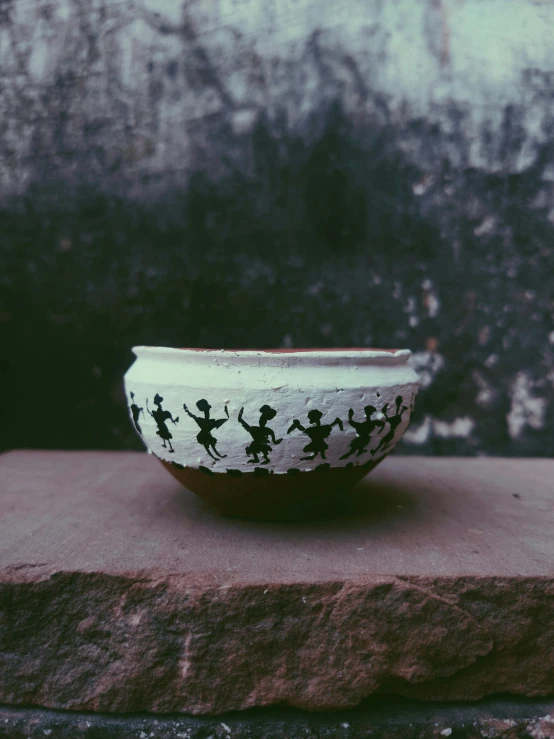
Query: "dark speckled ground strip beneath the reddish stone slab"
0 699 554 739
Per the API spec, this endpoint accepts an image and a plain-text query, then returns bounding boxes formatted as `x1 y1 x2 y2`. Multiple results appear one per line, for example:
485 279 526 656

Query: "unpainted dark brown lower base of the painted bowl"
160 457 384 521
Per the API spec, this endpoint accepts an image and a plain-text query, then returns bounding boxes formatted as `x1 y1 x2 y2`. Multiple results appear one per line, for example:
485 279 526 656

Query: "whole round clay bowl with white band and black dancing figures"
125 346 418 519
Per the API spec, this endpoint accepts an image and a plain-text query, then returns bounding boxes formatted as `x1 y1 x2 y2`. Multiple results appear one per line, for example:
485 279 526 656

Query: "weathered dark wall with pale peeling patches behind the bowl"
0 0 554 456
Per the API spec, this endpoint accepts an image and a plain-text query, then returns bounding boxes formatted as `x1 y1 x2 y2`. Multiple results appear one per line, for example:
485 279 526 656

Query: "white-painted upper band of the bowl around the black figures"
125 347 417 473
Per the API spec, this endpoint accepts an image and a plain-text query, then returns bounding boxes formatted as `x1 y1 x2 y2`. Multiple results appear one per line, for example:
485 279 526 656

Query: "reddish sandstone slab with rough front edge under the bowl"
0 452 554 714
